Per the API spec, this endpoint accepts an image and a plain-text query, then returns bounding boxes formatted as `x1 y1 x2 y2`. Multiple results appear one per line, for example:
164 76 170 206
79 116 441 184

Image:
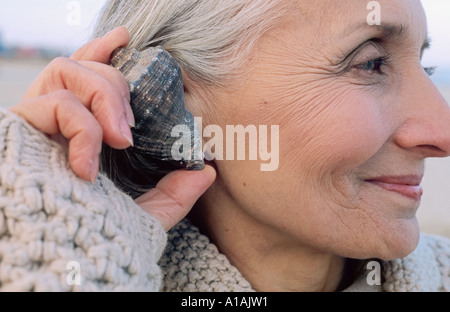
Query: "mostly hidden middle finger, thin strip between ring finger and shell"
79 61 136 128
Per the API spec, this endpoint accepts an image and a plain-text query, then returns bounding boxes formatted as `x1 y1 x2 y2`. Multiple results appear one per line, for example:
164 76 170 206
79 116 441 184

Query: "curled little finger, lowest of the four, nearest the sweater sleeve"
10 90 103 182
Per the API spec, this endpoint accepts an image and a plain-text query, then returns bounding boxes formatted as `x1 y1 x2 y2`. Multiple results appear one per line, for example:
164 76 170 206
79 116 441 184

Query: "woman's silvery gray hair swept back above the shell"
94 0 286 85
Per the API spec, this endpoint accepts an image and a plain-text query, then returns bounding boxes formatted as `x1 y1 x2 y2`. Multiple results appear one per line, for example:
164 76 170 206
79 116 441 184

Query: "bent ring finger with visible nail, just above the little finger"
25 58 133 149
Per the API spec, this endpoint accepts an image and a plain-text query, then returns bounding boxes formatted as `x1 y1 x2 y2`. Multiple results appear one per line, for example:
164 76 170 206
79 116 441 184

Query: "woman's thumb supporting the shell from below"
136 166 216 231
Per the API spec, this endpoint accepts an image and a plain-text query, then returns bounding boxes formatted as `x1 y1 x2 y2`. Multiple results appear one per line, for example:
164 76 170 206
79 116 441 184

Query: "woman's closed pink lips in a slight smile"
366 175 423 201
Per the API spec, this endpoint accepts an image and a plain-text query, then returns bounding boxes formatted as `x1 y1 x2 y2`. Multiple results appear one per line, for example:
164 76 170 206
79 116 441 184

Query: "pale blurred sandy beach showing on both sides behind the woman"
0 59 450 237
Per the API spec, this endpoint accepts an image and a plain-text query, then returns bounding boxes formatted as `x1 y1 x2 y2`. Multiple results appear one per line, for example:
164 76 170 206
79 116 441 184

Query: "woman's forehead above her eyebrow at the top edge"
284 0 427 50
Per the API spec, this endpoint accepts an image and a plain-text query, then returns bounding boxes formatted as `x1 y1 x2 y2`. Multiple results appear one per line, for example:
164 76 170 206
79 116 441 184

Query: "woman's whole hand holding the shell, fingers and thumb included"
10 27 215 230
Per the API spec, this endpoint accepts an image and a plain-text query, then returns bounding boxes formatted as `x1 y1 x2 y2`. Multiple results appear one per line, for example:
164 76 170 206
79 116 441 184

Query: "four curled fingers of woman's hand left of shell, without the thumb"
10 28 134 182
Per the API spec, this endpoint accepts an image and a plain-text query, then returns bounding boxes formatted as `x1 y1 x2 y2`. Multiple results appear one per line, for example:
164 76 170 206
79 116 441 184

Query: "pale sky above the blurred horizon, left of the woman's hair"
0 0 105 52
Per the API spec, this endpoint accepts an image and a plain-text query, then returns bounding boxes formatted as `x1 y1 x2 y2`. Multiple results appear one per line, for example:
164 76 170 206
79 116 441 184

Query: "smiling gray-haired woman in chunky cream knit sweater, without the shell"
0 0 450 291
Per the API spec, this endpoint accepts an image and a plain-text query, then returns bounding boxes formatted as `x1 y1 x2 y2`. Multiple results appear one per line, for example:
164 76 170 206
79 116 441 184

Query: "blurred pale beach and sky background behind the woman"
0 0 450 237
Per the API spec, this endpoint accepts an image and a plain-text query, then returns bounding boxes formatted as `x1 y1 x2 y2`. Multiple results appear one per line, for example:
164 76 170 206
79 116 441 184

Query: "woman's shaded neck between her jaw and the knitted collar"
191 186 345 292
